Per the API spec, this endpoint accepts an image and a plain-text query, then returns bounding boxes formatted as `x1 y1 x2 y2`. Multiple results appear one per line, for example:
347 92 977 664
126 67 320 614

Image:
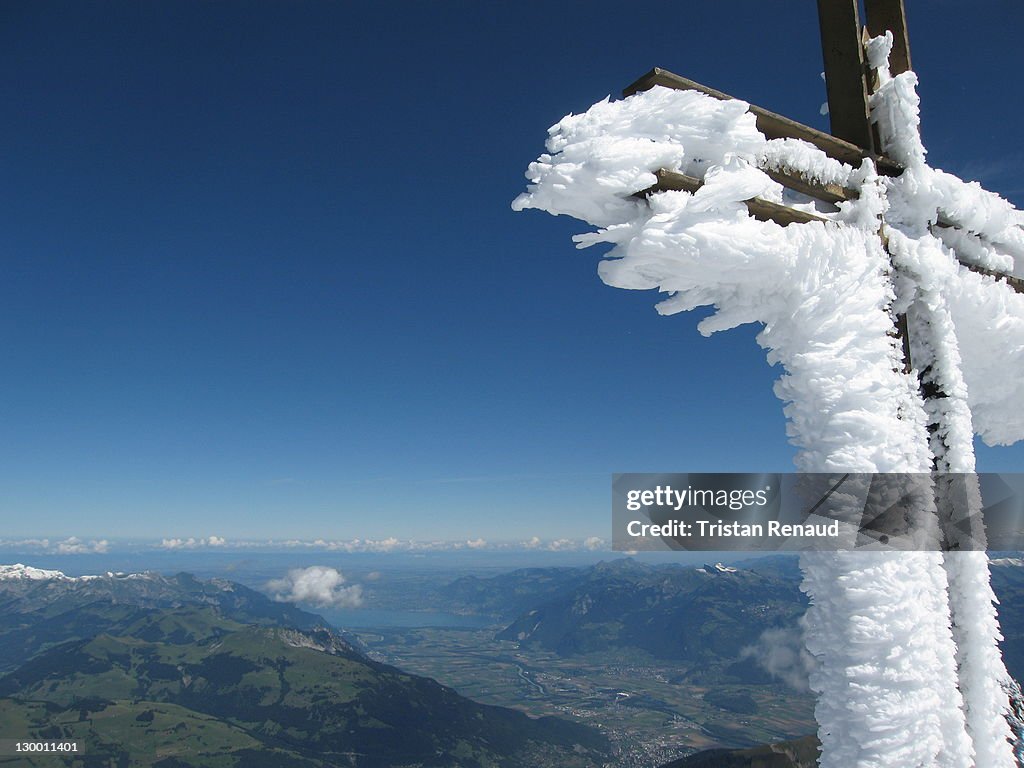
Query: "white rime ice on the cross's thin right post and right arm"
868 35 1024 768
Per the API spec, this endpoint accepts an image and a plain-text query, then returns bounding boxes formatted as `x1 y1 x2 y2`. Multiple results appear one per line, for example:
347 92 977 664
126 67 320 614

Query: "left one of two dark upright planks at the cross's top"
818 0 874 151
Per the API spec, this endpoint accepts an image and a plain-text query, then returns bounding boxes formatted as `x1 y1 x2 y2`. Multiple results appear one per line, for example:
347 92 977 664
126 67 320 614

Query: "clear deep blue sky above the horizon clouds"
0 0 1024 539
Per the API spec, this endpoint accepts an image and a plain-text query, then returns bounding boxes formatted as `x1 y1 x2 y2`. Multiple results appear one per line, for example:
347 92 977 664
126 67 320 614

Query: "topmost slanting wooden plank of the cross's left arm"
623 67 903 176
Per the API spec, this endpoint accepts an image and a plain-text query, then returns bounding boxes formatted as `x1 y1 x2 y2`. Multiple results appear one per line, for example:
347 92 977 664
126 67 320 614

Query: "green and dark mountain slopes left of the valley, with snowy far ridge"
0 566 608 768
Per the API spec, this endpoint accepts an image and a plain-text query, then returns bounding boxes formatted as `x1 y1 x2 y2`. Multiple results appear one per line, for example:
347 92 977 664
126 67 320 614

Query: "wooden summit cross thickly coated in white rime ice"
514 0 1024 768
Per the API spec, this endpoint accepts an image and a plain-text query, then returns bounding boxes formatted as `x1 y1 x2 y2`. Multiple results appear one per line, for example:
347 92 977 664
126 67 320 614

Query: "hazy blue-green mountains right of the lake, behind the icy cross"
446 555 1024 683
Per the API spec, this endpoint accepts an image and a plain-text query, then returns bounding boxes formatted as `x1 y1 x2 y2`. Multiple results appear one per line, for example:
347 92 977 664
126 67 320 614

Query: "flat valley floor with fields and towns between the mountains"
352 628 816 768
